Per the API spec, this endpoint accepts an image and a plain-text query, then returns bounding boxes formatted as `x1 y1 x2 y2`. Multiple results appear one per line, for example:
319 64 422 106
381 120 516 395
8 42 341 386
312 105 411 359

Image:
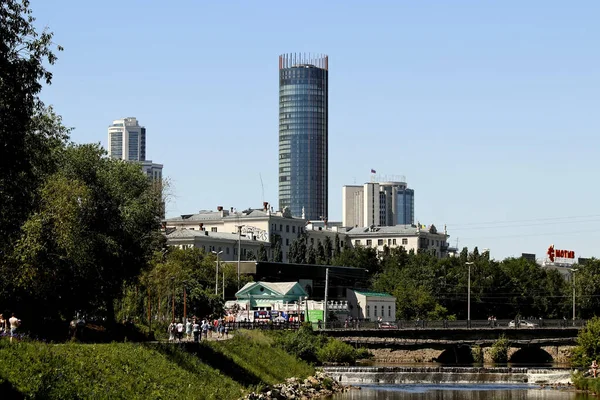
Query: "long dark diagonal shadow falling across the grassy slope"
147 343 264 387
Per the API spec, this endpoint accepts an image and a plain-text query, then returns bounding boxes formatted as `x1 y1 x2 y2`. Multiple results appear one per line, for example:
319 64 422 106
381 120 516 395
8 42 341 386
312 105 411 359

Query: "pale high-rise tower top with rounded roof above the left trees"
108 117 146 161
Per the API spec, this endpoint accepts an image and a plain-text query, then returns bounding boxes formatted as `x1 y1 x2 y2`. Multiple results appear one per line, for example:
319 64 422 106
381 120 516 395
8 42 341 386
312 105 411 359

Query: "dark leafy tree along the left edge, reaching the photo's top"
0 0 69 253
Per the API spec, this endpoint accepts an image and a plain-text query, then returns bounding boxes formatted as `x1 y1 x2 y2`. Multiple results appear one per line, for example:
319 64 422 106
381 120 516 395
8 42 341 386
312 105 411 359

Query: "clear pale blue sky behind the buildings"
32 0 600 258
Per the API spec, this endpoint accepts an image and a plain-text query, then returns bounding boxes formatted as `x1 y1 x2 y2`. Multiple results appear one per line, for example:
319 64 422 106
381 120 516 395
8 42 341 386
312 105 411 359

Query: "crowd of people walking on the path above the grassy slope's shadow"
167 318 229 342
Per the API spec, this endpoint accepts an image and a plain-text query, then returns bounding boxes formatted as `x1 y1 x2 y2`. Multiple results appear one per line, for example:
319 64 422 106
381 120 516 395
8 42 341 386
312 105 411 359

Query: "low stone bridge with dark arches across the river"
323 327 578 364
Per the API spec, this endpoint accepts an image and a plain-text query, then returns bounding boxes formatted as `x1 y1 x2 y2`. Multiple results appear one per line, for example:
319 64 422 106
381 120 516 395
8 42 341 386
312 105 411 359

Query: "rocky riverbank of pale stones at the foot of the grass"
241 371 360 400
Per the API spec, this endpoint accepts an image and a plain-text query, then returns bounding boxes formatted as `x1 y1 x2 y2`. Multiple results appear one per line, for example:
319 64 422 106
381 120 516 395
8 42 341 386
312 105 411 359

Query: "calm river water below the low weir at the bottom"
330 384 597 400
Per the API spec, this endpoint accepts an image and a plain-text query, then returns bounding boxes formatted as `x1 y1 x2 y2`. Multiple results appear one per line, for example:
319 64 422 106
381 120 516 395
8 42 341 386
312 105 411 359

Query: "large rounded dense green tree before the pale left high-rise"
15 145 164 321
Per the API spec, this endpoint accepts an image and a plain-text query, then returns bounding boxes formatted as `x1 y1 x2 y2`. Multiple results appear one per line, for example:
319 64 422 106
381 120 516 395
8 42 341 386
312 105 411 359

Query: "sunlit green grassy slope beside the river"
0 332 314 400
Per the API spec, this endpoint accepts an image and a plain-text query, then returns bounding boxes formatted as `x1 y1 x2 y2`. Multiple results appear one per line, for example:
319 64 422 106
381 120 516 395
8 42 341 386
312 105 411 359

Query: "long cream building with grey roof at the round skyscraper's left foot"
163 202 306 262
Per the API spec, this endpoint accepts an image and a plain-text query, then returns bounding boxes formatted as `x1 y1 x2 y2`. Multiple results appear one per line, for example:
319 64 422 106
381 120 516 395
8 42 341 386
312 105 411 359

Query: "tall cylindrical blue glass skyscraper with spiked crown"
279 53 328 220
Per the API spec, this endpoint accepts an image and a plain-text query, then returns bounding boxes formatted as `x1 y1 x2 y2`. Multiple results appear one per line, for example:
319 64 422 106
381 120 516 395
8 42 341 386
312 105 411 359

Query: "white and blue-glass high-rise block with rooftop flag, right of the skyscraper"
342 181 415 227
